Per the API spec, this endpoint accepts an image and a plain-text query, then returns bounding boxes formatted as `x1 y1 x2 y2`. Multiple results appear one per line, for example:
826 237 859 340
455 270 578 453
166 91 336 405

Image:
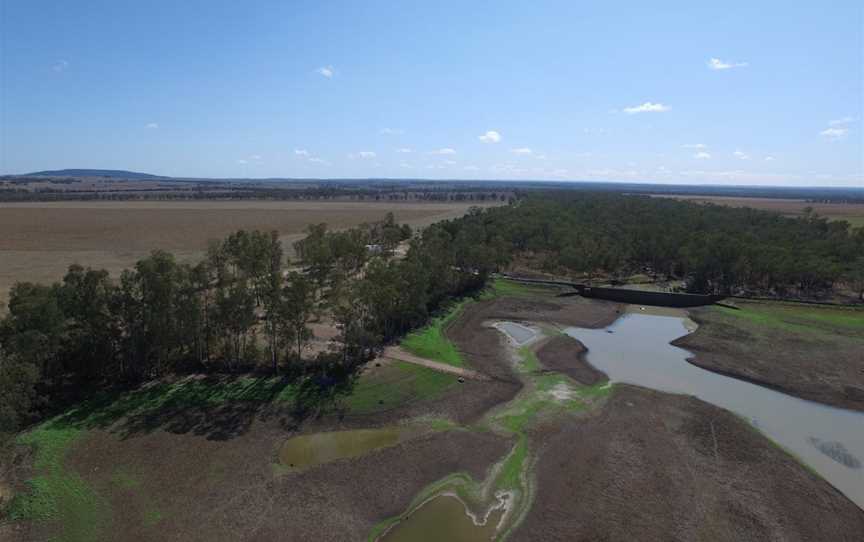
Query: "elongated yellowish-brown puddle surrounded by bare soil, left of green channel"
279 427 411 469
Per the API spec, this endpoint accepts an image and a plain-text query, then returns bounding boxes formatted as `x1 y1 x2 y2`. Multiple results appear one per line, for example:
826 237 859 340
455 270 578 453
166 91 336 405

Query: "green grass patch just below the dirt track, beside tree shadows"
345 361 458 414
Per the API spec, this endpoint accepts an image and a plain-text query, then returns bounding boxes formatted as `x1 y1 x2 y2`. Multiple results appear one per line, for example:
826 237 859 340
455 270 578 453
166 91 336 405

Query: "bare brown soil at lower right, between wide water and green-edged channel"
513 384 864 542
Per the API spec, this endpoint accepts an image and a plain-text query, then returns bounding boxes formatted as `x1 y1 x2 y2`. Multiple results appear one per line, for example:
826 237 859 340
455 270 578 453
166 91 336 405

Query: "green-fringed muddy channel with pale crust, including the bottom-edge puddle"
369 322 612 542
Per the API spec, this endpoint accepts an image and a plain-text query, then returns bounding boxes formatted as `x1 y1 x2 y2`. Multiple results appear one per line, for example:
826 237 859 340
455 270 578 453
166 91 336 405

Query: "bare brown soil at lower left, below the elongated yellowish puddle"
69 424 512 541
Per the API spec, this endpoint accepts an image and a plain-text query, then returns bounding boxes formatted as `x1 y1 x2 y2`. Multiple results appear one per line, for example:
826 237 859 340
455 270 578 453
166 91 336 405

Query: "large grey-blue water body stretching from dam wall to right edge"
565 313 864 508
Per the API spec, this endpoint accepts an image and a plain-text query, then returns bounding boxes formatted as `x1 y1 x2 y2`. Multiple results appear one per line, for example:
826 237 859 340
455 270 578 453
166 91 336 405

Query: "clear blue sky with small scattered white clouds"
0 0 864 186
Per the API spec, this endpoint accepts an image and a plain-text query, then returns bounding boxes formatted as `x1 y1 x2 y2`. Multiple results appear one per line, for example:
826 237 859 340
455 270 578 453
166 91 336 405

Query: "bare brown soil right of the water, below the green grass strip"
672 309 864 411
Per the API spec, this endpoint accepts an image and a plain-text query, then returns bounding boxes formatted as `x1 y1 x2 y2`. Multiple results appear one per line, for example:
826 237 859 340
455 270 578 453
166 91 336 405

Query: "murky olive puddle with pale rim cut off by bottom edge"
379 494 507 542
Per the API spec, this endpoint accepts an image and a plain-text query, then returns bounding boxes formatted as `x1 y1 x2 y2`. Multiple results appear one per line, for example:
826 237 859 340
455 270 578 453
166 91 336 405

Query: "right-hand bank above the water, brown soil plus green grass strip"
674 302 864 411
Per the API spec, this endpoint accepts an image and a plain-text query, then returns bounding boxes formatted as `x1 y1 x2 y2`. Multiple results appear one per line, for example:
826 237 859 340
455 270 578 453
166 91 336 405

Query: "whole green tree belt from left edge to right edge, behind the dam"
0 191 864 444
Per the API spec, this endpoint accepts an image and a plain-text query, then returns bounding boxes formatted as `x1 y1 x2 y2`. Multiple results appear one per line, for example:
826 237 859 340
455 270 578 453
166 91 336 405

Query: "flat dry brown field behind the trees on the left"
0 201 492 303
